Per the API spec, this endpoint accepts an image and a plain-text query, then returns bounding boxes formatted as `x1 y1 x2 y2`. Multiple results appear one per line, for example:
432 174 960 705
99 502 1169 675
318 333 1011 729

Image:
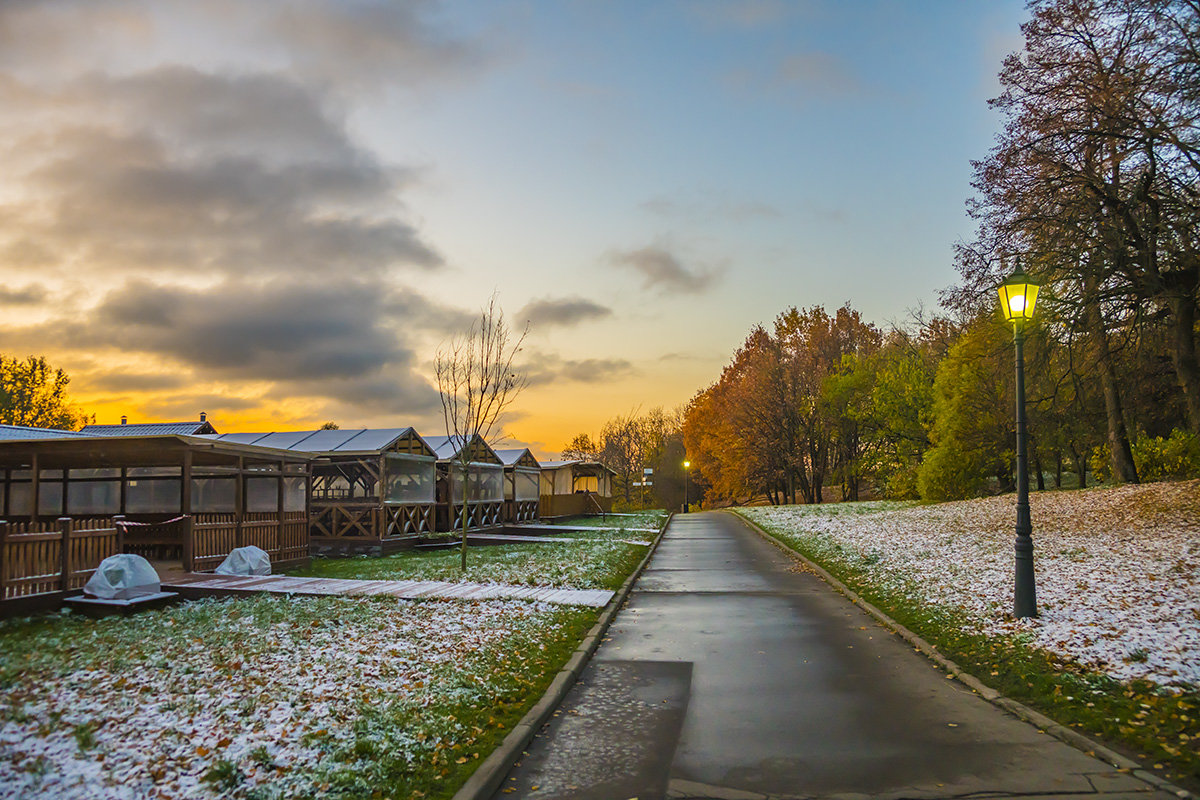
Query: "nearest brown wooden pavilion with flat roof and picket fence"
0 434 308 606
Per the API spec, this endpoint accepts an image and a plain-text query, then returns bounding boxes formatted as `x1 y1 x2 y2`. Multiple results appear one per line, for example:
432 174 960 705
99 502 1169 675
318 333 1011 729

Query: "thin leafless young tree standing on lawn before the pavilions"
434 294 529 571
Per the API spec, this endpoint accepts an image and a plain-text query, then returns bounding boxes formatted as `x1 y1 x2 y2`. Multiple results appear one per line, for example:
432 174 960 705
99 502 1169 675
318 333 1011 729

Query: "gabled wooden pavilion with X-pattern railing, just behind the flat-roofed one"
200 428 437 555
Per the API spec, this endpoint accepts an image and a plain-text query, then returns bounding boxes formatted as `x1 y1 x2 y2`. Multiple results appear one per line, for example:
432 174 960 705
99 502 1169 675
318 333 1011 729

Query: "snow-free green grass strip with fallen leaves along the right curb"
729 503 1200 790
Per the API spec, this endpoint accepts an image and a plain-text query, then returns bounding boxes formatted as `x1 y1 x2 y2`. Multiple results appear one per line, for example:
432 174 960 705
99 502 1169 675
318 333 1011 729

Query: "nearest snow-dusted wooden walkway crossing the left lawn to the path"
162 572 613 608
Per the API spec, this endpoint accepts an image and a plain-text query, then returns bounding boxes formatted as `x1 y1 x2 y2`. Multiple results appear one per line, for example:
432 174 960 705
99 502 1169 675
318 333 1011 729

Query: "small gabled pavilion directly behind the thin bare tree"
425 435 504 533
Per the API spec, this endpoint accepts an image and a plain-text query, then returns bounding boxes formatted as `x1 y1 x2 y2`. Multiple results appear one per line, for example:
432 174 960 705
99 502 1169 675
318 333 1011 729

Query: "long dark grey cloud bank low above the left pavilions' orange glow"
0 279 438 414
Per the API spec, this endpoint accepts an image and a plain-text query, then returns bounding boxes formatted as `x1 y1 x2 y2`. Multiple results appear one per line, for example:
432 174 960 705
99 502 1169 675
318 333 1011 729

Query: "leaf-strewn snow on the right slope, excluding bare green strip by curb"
740 481 1200 686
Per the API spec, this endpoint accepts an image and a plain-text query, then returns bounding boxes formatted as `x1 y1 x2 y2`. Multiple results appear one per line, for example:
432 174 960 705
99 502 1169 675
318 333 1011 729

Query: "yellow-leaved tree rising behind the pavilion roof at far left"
0 354 88 431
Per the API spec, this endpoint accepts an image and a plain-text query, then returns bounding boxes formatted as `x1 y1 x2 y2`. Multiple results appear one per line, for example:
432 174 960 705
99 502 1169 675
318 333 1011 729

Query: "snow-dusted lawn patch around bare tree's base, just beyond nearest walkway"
296 531 653 589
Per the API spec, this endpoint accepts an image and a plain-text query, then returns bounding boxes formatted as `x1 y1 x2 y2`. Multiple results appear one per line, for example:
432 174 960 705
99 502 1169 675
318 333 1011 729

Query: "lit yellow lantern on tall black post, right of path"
1000 260 1039 619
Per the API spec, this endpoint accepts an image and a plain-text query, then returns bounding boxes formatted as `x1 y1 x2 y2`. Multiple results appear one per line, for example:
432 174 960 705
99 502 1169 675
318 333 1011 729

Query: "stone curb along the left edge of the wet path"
451 512 674 800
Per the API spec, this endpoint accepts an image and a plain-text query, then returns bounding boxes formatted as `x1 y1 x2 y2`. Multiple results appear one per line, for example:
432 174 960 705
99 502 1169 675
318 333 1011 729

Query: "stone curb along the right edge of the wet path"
726 512 1196 800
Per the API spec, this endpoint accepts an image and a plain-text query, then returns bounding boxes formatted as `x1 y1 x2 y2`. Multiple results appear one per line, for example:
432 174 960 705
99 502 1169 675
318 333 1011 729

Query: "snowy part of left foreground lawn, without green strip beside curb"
0 599 580 800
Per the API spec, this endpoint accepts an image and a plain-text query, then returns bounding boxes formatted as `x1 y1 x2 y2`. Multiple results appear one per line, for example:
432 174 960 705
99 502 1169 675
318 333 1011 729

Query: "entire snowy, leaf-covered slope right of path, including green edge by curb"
739 481 1200 790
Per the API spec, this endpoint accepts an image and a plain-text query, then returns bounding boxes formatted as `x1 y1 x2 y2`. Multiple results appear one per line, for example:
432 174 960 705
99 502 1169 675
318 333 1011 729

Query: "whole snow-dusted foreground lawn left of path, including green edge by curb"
0 597 595 799
